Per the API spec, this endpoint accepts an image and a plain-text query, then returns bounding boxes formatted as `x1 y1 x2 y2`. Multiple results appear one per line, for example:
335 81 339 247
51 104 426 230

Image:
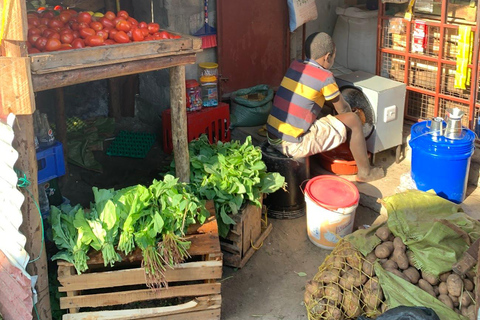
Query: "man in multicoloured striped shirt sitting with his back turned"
267 32 385 182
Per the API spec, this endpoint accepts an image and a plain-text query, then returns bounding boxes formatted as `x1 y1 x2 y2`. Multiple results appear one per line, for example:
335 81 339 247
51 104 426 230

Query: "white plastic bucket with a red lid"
305 175 360 250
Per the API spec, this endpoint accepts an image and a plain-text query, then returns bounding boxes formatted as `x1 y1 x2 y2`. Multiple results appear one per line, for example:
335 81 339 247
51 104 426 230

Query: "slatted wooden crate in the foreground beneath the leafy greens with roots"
58 209 222 320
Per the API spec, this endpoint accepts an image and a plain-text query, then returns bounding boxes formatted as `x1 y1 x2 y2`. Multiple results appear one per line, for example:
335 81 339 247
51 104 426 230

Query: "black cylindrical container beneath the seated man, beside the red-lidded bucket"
261 141 310 219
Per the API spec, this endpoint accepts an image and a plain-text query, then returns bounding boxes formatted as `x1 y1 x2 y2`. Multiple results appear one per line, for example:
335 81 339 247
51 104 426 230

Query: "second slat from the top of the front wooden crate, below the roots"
60 283 221 309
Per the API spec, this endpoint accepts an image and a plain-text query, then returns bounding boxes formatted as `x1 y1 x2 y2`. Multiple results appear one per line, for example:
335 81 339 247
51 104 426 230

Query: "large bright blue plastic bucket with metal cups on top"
409 120 475 203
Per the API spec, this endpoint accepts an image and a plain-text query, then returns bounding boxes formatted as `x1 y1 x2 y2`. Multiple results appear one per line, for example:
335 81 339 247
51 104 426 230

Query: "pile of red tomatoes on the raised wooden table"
27 9 180 53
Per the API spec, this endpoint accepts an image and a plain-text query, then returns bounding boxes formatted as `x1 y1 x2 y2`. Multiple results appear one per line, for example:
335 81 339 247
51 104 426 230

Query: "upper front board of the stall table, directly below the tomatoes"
30 35 201 74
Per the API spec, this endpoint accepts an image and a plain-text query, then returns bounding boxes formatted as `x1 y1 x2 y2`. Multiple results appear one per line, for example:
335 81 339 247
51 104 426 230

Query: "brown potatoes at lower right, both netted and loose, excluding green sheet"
304 226 475 320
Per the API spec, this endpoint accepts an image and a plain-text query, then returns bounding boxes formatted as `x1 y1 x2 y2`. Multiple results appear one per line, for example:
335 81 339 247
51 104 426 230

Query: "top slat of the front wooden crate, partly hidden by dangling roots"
58 261 222 292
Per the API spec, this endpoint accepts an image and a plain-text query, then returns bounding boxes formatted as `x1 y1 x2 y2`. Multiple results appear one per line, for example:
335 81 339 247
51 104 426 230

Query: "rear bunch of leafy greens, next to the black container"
172 135 285 237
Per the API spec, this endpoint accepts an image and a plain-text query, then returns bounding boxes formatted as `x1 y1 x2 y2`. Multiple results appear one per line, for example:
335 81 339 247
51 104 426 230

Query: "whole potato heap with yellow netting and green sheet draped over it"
304 190 480 320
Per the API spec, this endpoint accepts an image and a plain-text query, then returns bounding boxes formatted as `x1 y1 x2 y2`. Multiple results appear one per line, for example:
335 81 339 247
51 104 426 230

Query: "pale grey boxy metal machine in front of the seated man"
336 71 406 163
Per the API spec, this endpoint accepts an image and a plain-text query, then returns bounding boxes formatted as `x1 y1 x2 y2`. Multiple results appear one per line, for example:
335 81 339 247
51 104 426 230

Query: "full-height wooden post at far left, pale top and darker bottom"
0 0 52 320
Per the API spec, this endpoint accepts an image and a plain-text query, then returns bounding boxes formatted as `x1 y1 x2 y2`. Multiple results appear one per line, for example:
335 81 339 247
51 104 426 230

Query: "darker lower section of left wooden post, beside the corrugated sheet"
12 115 52 319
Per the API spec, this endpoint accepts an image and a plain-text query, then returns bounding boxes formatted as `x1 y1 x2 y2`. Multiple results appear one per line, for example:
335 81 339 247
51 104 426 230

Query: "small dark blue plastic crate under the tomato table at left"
37 141 65 184
